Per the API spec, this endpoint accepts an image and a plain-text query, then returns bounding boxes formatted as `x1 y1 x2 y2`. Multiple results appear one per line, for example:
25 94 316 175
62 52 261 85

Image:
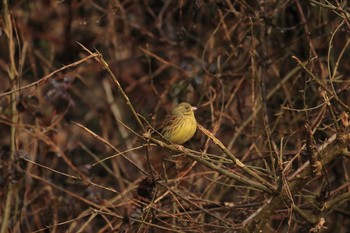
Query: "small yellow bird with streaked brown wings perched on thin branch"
157 102 197 145
